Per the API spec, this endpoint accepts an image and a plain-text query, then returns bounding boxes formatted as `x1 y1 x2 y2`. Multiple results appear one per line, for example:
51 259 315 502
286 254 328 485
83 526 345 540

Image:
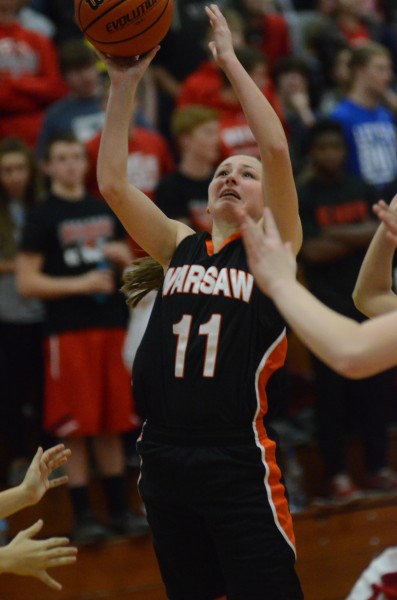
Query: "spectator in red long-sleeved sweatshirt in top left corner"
0 0 66 148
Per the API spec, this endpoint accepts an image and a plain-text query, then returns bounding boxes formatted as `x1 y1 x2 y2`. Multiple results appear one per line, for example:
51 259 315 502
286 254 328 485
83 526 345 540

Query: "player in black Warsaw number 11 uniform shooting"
98 4 303 600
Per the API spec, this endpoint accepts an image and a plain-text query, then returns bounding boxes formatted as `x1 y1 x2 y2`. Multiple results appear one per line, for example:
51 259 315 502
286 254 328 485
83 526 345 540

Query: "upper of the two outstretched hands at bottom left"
21 444 71 504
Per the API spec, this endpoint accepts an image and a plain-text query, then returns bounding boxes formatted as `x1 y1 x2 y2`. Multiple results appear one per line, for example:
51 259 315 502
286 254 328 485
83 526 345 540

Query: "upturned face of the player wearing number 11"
208 155 263 222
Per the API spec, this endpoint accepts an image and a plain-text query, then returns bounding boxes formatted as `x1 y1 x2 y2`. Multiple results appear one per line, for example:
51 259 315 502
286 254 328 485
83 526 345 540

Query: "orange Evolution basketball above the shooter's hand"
74 0 174 58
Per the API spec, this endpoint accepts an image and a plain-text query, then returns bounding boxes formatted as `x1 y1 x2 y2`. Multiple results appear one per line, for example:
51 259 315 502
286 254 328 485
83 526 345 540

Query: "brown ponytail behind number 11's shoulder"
121 256 164 308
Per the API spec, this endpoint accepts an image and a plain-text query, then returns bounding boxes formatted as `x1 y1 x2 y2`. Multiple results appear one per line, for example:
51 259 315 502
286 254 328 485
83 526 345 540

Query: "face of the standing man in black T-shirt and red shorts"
46 141 88 188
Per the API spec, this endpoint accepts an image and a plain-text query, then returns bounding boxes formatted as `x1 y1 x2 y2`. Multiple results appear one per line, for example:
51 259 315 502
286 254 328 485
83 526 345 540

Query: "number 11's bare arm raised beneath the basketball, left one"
97 48 193 265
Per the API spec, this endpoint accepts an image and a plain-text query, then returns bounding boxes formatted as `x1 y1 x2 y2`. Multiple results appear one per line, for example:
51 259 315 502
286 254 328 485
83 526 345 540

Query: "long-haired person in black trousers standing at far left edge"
0 138 44 485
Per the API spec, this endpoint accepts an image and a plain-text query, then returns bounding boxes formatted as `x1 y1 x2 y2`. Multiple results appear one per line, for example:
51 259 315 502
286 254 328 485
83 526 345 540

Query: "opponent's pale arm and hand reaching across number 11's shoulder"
239 208 397 379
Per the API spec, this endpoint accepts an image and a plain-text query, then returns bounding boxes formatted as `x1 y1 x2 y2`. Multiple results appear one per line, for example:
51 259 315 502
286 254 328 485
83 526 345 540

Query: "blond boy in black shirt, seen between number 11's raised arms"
156 106 219 231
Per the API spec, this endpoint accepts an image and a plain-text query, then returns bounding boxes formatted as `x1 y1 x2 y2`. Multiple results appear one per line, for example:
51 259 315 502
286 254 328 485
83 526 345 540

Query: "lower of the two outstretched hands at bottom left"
0 520 77 591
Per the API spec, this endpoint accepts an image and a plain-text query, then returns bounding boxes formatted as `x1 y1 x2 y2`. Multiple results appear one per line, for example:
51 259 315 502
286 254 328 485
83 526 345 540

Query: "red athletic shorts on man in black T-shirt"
44 328 139 438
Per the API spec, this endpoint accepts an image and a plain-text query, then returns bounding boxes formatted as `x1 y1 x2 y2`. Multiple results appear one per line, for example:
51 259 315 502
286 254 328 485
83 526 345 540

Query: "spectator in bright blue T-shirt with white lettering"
330 42 397 192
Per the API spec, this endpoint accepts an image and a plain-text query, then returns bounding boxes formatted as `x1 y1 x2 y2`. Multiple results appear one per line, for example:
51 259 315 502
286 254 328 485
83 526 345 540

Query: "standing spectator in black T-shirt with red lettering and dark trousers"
298 121 397 502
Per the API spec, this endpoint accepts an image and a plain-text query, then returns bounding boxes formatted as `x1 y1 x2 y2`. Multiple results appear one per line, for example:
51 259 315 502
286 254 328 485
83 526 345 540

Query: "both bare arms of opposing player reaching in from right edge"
235 196 397 379
